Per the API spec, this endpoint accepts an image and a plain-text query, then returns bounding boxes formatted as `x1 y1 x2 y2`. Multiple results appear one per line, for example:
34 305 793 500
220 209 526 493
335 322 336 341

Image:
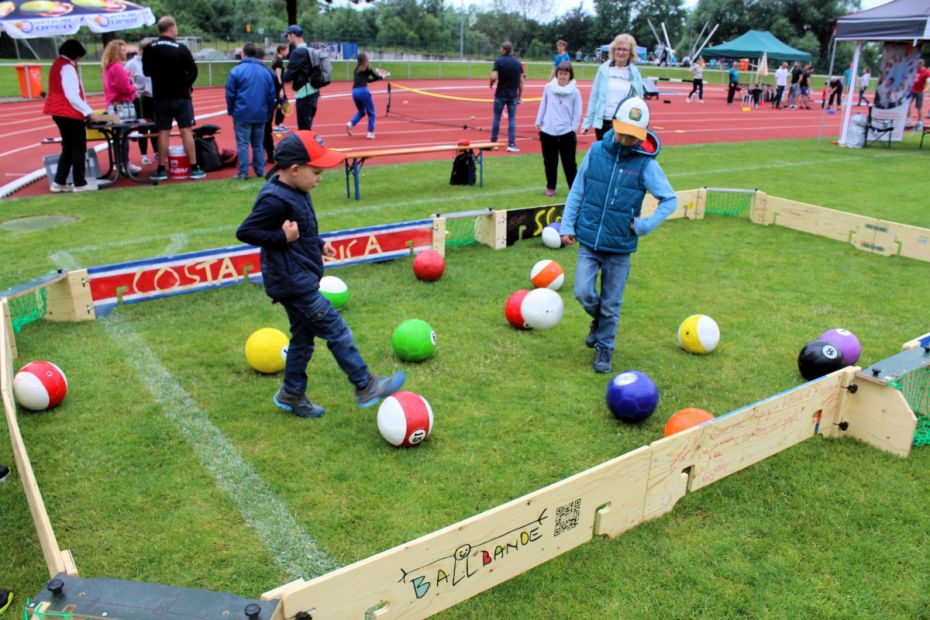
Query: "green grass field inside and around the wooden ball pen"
0 136 930 618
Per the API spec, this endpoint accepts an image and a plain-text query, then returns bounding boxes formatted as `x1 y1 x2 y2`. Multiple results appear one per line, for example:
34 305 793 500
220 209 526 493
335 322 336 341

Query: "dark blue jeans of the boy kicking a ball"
280 290 370 394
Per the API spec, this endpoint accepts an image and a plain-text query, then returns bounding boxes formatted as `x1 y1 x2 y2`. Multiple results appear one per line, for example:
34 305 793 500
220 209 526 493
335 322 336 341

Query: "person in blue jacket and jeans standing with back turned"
226 43 277 181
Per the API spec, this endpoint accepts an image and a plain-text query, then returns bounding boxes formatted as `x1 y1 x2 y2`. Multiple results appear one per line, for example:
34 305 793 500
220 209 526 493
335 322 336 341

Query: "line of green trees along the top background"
70 0 875 71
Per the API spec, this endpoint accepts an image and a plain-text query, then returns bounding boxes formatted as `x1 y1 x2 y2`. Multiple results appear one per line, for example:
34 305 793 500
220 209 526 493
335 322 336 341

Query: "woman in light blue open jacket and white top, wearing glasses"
581 33 643 140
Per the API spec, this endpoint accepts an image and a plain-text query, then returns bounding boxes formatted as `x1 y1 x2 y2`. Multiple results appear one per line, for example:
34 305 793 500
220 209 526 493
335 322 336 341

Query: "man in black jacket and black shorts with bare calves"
142 15 207 181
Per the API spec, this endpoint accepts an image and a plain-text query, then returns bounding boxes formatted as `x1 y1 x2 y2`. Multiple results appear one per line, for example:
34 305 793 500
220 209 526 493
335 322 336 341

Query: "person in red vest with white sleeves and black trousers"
42 39 97 192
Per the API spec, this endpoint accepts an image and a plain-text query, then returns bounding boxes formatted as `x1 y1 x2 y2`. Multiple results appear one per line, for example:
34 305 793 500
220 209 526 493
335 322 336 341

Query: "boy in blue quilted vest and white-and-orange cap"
560 97 678 373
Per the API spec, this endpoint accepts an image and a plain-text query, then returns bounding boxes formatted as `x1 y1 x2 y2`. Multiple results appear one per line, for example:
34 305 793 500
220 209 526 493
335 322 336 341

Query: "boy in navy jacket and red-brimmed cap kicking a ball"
236 131 405 418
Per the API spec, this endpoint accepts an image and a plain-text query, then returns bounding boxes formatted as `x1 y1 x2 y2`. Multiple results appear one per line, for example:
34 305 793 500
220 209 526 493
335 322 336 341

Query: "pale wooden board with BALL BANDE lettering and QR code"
262 447 649 620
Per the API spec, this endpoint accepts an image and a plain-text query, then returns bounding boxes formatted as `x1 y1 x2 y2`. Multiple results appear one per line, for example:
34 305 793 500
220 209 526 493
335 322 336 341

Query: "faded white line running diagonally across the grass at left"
59 252 338 578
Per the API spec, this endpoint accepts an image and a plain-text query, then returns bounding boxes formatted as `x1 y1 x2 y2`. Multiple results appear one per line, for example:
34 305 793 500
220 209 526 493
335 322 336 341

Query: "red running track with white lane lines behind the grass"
0 80 841 197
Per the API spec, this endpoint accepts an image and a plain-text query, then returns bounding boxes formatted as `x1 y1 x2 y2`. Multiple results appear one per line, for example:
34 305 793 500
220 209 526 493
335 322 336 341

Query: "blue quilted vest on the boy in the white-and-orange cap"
575 130 659 254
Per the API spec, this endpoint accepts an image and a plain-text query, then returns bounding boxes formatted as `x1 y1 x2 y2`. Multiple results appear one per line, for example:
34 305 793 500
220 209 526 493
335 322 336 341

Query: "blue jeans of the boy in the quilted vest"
575 244 630 351
